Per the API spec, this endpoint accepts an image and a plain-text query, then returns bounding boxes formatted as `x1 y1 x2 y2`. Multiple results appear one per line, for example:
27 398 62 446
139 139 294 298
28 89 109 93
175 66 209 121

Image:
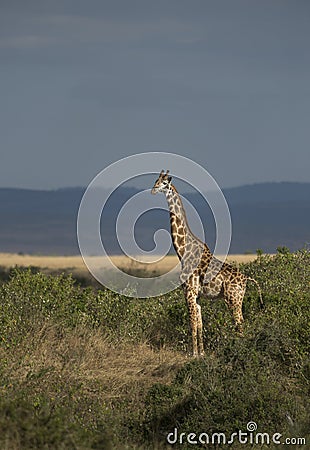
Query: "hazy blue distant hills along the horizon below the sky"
0 183 310 255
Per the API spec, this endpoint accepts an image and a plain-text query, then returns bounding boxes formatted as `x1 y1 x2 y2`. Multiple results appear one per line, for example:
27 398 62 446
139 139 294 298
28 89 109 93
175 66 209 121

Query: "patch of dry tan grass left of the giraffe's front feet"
9 324 188 402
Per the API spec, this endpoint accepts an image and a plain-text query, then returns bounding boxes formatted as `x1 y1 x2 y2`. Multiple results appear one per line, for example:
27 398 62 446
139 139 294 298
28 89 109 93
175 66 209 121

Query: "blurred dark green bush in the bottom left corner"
0 380 112 450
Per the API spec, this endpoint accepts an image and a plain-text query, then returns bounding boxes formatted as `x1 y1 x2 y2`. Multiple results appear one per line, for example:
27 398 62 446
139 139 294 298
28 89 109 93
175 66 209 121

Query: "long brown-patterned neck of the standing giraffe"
165 185 194 260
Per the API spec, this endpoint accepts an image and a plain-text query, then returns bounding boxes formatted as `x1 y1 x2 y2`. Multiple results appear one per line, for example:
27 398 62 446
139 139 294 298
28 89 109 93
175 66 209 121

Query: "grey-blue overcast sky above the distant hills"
0 0 310 189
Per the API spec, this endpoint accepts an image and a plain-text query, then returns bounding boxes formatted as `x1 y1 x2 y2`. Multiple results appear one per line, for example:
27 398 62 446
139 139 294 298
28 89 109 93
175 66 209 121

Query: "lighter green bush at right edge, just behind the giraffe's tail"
241 249 310 355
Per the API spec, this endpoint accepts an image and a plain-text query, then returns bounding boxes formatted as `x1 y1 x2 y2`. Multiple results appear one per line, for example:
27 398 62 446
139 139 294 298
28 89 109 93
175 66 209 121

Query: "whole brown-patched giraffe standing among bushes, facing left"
151 170 263 357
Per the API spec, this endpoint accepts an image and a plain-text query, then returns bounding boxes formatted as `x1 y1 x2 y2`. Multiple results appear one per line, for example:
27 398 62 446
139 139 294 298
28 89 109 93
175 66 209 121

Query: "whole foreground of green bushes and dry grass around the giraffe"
0 248 310 450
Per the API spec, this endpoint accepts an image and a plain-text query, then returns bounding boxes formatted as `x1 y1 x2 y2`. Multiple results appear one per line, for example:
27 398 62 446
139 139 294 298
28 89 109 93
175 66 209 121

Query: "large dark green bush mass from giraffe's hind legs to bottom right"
144 250 310 448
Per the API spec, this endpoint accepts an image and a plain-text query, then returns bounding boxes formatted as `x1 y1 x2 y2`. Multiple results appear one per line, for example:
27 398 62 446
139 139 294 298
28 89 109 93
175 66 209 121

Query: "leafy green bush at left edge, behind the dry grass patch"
0 270 95 346
